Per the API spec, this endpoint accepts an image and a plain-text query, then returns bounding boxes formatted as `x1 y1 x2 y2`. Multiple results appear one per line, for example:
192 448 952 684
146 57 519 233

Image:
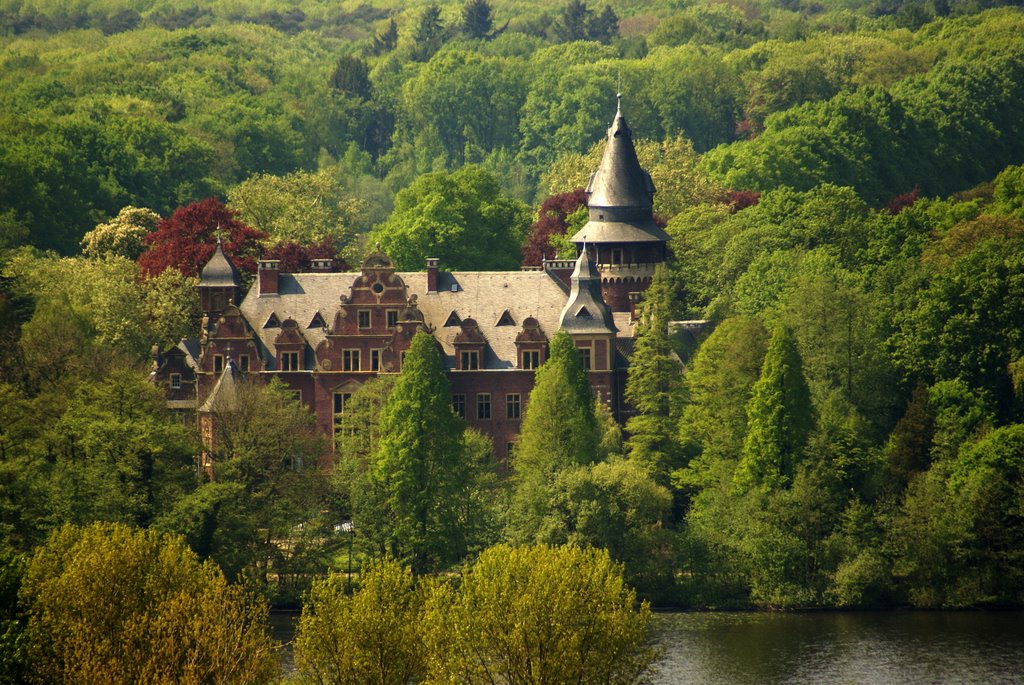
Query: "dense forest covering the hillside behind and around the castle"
0 0 1024 671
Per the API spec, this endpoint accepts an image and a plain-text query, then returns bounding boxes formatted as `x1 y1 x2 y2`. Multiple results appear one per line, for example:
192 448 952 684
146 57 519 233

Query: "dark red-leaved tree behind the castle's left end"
138 198 266 277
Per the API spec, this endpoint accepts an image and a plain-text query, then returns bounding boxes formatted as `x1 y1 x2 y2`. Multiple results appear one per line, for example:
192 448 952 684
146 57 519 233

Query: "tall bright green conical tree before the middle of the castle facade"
370 333 471 572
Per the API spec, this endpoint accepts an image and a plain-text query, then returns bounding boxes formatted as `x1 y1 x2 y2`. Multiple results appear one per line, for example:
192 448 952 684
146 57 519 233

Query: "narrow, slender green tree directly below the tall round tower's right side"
626 264 682 485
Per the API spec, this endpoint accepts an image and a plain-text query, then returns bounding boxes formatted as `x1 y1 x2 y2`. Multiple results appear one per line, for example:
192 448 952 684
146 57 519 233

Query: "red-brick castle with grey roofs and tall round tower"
148 98 668 460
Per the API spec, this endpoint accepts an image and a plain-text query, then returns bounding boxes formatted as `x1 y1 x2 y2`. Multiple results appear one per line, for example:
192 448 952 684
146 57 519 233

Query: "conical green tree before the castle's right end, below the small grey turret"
507 331 601 542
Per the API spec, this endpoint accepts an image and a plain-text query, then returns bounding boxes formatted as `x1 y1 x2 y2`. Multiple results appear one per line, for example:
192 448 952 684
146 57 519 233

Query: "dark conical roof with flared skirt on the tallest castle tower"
572 95 669 244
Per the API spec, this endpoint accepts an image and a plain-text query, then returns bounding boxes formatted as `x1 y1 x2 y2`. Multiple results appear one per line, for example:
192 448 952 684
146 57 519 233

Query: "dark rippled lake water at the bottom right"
653 611 1024 685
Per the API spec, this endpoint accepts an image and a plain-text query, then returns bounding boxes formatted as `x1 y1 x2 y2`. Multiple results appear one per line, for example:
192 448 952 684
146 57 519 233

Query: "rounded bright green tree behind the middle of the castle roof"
371 166 530 269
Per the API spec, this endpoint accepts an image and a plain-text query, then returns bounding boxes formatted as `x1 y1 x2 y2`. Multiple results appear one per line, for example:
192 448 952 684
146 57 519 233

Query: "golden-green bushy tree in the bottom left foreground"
20 523 278 683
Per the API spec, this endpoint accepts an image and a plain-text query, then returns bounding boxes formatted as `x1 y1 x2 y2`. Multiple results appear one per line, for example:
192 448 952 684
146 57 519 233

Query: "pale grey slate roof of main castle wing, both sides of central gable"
239 271 567 369
